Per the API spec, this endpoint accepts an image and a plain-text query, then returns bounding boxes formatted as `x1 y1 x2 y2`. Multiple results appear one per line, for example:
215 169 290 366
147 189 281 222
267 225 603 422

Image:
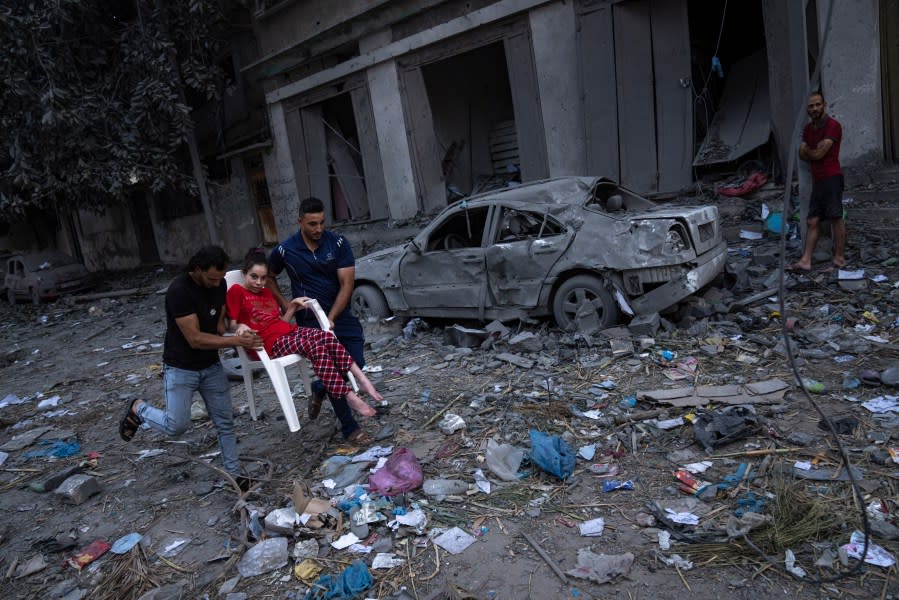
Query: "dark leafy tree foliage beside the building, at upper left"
0 0 227 221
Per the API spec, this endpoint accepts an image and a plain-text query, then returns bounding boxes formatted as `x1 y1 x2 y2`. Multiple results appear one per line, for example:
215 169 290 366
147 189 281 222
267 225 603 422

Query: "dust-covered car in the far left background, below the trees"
3 250 95 304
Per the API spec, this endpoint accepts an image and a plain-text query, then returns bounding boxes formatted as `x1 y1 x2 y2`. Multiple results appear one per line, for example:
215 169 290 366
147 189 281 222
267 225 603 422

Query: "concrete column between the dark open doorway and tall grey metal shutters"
529 2 587 177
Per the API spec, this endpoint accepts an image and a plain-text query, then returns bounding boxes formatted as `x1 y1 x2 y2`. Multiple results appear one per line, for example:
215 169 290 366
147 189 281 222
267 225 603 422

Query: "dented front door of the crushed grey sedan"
399 204 491 317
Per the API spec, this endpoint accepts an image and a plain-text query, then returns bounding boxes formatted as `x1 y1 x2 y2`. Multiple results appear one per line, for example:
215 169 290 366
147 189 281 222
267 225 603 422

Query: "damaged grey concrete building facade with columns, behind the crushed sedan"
244 0 896 244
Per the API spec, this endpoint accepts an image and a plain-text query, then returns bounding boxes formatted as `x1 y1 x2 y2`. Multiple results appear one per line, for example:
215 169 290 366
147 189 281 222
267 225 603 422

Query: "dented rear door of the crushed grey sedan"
485 206 573 308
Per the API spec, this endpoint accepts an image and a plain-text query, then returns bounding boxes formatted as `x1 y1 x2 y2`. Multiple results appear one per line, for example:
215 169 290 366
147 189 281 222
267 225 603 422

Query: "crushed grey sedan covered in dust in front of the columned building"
351 177 727 330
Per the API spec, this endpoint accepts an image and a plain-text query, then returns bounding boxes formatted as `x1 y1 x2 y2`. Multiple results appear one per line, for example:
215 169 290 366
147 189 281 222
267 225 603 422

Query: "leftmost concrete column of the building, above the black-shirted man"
262 102 300 240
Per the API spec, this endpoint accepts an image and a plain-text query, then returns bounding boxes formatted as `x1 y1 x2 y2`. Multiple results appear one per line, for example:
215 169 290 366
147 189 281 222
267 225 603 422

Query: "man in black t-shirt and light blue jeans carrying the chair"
119 246 262 488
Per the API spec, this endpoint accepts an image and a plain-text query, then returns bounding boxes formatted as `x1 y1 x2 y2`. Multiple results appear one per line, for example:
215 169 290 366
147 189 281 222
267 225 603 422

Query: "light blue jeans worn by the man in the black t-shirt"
137 363 240 475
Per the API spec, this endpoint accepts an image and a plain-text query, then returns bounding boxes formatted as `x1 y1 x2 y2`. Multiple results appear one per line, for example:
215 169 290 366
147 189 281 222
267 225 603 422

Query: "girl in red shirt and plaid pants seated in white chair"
226 250 383 417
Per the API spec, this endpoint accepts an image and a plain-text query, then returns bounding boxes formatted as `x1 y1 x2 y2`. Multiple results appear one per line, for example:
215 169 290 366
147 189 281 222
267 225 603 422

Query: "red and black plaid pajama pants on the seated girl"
272 327 353 398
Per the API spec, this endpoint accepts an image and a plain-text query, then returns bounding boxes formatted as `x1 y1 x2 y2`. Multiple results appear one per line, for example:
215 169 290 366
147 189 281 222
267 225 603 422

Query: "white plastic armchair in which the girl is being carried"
225 269 359 432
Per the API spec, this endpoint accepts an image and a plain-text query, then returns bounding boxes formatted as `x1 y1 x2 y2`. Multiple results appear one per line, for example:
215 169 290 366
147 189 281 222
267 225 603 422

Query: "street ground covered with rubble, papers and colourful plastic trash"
0 198 899 600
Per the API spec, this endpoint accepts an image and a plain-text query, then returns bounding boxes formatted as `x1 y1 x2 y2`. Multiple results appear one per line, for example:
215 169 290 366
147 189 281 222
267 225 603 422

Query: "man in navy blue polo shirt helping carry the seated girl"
267 197 374 446
